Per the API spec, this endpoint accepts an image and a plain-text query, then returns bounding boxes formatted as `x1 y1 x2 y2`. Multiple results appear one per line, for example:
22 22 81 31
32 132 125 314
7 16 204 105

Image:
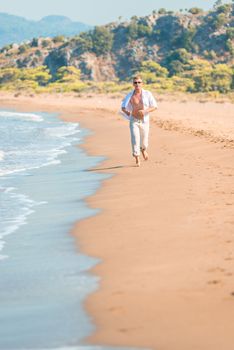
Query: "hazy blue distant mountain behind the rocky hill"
0 13 91 47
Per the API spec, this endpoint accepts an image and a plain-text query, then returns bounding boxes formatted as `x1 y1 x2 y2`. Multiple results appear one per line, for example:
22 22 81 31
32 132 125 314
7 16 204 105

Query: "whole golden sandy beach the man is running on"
0 94 234 350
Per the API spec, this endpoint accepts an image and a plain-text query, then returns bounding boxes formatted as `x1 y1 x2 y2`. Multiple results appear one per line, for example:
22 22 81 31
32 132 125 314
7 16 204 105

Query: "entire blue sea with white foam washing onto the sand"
0 110 137 350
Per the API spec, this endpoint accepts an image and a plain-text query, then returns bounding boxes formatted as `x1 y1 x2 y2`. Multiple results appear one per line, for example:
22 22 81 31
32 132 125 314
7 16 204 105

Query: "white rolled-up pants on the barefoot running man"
129 117 149 156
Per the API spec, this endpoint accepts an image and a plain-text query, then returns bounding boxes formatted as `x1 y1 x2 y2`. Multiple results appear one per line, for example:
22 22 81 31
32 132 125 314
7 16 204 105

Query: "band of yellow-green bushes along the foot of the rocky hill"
0 58 234 93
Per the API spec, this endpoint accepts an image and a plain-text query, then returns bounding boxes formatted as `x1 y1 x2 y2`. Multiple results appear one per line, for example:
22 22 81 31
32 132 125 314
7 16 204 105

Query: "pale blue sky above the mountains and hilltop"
0 0 231 25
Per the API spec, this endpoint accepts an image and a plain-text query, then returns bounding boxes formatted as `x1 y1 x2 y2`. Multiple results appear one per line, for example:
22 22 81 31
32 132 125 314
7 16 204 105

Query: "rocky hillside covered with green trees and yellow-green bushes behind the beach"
0 4 234 92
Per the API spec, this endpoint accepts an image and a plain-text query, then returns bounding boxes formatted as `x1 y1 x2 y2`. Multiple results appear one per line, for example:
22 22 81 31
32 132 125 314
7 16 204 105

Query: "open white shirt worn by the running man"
121 89 158 122
